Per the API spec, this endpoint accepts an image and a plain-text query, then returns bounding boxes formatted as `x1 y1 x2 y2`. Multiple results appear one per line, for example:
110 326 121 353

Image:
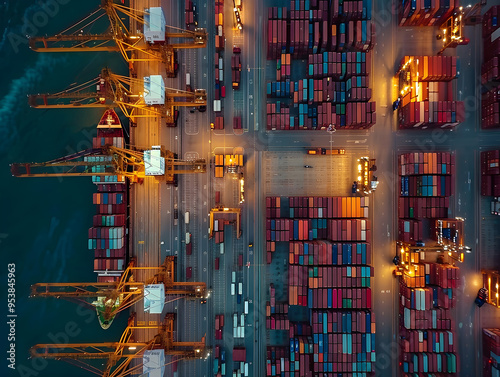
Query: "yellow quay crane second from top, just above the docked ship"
28 68 207 125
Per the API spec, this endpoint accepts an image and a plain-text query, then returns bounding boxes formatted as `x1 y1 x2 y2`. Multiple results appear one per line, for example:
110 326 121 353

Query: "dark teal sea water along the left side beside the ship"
0 0 127 377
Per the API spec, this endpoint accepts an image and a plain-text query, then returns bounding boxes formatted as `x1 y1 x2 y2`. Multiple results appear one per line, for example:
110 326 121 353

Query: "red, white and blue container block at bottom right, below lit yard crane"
399 263 459 376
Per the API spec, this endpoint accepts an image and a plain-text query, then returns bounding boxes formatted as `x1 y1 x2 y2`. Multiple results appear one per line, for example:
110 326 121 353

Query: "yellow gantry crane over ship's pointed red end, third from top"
11 145 206 183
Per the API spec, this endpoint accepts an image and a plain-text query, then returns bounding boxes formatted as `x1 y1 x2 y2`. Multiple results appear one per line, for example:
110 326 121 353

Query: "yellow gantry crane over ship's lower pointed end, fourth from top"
31 256 207 329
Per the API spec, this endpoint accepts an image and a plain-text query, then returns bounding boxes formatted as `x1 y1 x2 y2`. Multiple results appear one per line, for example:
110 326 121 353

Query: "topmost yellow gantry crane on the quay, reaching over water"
29 0 207 77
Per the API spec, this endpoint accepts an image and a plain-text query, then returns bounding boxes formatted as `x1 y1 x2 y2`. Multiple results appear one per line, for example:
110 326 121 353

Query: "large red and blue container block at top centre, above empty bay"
266 0 376 130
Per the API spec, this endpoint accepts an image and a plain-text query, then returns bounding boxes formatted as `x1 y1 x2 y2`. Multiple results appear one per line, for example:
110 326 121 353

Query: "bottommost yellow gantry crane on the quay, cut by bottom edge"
30 313 208 377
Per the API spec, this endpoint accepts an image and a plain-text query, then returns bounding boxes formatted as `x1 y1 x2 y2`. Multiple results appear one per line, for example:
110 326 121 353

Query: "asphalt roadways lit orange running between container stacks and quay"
126 0 500 376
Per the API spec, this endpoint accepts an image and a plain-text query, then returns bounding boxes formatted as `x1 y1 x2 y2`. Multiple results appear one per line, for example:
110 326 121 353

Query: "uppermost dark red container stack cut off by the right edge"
481 5 500 85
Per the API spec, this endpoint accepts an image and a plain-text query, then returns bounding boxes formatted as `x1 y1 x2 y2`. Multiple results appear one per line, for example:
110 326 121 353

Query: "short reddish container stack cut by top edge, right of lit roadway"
397 0 459 26
